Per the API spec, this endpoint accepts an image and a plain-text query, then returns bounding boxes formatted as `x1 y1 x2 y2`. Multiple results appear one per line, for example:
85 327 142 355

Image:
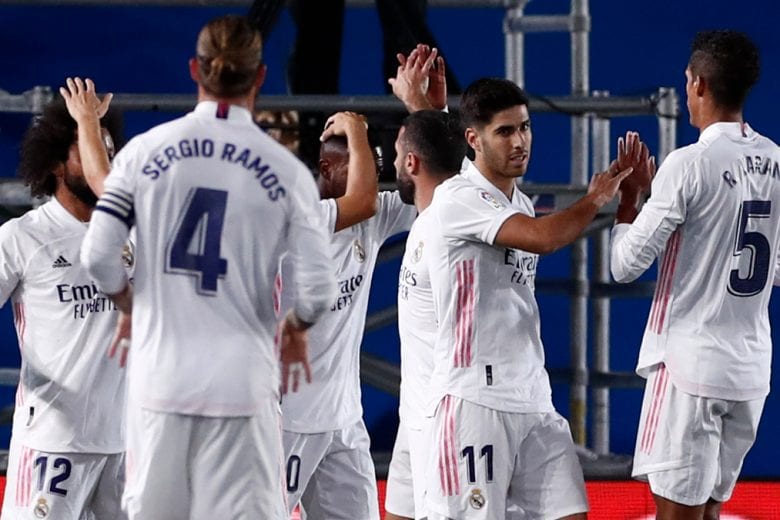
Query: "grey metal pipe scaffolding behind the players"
0 0 679 464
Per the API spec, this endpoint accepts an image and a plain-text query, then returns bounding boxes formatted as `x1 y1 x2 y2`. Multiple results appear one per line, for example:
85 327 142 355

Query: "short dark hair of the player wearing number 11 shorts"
459 78 528 127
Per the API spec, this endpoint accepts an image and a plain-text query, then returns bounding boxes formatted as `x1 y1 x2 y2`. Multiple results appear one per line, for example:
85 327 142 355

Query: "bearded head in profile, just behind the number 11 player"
394 110 466 204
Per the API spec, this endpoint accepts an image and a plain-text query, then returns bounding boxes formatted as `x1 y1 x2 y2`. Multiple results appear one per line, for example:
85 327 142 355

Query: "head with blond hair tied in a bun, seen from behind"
190 15 265 99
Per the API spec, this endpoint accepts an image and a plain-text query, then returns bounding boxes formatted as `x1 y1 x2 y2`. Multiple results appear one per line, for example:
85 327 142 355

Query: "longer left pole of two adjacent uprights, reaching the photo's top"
569 0 590 446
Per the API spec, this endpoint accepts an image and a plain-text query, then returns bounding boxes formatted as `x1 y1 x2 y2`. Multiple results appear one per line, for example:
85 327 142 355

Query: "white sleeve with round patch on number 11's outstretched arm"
437 185 520 245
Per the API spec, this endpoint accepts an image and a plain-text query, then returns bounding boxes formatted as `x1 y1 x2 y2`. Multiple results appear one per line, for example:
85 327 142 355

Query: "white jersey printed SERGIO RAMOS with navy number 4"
82 101 335 417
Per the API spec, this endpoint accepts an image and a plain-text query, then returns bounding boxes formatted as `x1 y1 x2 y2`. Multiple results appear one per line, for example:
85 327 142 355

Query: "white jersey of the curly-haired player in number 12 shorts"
0 198 125 453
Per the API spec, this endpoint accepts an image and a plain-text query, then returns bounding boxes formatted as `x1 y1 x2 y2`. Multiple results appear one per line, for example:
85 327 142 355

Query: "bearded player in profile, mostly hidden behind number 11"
385 110 466 520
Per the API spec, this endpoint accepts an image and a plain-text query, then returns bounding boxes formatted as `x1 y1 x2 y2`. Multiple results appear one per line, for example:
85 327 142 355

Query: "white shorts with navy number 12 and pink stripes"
0 438 126 520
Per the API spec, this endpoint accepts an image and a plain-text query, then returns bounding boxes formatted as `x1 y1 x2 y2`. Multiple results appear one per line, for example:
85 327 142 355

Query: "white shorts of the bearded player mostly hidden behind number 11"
385 421 430 519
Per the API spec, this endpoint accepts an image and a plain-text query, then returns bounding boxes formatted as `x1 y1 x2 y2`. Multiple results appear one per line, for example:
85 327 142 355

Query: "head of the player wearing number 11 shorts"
460 78 532 181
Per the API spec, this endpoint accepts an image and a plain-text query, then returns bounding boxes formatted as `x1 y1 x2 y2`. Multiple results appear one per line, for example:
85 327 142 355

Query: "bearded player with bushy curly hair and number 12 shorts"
0 99 125 520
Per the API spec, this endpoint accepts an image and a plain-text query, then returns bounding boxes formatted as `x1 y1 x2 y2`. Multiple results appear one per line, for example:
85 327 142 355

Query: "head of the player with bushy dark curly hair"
19 99 122 206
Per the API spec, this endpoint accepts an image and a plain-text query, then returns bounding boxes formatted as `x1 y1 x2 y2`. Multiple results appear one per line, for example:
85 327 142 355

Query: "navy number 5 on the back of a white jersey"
728 200 772 296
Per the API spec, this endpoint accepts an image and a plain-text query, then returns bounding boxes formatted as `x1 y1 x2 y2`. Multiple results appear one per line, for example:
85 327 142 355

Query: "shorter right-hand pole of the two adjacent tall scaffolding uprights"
592 91 610 455
